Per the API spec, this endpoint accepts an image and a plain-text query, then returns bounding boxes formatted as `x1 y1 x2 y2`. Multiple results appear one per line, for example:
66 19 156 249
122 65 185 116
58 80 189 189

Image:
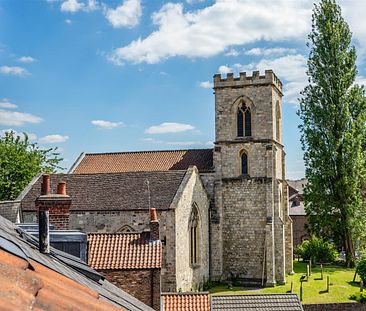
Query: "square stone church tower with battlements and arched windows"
211 70 292 285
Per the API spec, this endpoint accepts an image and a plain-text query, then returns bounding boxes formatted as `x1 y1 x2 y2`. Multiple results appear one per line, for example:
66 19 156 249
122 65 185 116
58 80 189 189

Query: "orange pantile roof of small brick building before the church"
88 233 162 270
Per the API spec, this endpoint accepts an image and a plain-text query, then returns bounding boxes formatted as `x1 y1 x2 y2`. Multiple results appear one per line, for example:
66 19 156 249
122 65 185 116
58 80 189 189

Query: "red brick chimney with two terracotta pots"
36 175 71 230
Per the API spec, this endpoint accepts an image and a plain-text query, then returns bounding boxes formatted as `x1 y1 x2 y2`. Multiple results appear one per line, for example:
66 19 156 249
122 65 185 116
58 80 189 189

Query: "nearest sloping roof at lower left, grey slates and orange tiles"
0 217 152 311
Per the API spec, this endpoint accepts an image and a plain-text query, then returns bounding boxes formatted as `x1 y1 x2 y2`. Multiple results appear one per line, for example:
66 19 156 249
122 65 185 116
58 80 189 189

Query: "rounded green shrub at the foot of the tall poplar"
297 236 338 263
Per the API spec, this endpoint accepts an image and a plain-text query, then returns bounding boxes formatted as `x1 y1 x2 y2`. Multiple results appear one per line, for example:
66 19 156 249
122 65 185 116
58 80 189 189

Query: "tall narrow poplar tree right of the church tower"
298 0 366 267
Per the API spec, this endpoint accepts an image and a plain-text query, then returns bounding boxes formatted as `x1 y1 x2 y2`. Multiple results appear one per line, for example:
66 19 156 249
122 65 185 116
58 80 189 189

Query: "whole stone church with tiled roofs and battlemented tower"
18 70 293 291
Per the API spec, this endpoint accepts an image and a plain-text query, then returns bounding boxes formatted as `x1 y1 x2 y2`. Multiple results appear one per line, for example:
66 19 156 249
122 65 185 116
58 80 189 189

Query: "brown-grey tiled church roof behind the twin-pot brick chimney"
21 171 186 211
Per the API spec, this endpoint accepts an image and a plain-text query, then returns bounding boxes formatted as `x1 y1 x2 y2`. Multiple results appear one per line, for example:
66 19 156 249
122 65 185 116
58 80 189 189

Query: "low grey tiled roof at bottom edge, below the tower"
211 294 303 311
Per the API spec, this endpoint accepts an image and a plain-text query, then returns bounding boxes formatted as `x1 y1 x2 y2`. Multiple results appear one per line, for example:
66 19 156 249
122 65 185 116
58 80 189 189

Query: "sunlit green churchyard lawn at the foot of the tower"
210 261 360 304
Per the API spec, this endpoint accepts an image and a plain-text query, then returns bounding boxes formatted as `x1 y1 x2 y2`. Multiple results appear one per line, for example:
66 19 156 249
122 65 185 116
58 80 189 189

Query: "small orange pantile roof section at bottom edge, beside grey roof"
161 293 210 311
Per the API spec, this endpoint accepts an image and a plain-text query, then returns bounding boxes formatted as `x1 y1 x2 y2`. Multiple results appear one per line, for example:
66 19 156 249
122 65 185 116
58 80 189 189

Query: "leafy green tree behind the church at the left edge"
0 132 62 201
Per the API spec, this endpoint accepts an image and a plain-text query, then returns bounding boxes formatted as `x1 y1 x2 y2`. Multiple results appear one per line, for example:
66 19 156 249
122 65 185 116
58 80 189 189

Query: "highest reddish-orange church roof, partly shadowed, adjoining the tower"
71 149 213 174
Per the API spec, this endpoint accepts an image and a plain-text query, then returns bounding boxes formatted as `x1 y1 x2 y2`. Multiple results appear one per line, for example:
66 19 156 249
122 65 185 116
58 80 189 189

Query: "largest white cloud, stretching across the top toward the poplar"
109 0 312 65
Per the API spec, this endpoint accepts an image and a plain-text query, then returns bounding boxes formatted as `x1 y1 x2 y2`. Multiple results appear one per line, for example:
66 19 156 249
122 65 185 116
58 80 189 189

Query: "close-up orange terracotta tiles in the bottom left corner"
0 249 123 310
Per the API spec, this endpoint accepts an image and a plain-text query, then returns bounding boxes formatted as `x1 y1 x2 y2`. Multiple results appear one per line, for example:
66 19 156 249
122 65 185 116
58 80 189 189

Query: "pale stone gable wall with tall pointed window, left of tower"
173 169 210 292
